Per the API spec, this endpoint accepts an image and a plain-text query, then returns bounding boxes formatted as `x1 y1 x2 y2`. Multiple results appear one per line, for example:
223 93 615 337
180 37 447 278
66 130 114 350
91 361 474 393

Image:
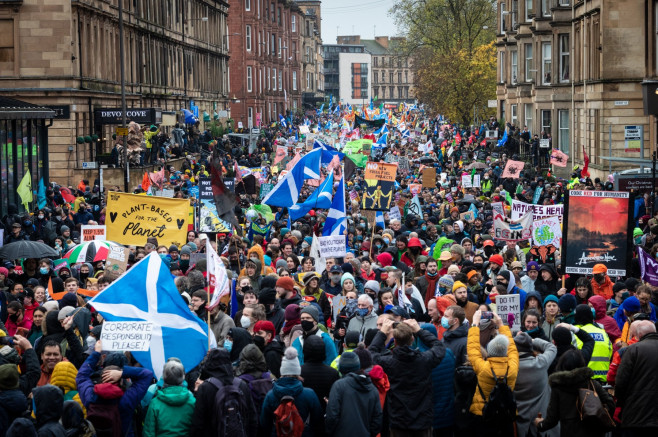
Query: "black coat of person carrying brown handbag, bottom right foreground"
538 367 619 437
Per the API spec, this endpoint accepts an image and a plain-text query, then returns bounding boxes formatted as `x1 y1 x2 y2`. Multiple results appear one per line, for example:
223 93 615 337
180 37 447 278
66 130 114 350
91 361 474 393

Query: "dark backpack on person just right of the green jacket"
208 378 249 437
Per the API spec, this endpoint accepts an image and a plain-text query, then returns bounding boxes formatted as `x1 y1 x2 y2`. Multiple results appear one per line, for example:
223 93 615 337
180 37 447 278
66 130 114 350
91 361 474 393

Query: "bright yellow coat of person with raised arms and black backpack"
466 326 519 416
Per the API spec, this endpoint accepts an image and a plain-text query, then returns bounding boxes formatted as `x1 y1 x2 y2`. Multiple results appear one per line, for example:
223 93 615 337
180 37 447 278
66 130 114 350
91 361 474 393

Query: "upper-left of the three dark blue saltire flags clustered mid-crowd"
261 149 322 208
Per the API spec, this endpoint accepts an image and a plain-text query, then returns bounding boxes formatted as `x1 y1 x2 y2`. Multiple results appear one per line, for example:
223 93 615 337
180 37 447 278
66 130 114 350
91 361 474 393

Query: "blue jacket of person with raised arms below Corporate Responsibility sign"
75 351 153 437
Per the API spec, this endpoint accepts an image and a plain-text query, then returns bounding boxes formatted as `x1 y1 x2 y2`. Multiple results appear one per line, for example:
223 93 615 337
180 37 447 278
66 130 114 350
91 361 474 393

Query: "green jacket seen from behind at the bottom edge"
143 386 196 437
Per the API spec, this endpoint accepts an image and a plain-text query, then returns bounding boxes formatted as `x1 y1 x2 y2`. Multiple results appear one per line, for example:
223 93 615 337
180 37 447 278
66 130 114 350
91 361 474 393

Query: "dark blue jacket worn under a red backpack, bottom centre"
260 377 324 437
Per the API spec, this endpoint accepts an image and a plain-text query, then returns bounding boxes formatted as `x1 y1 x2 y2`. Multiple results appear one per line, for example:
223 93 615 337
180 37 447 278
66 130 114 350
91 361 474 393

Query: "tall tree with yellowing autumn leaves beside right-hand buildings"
391 0 496 124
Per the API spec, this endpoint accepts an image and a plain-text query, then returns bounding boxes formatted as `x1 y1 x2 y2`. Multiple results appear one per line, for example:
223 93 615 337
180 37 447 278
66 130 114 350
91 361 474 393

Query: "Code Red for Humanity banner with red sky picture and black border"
562 190 634 276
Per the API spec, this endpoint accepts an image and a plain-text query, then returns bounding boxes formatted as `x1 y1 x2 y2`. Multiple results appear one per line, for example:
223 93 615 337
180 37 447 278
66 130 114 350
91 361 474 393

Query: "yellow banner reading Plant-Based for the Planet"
105 191 190 246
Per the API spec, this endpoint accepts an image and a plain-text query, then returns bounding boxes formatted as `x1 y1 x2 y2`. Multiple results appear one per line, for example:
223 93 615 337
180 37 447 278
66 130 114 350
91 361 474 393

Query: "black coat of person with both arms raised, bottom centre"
369 329 446 430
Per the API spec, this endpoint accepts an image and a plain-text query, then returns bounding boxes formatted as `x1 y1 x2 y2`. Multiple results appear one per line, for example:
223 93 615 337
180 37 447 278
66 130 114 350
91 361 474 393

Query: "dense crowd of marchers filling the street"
0 115 658 437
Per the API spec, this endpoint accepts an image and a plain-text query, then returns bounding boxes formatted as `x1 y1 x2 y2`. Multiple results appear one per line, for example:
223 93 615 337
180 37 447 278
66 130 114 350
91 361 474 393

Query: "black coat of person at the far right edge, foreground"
615 333 658 428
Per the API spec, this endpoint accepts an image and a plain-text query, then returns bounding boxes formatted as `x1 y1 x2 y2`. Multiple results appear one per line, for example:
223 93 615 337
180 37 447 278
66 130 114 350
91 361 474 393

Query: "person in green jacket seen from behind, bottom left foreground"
142 358 196 437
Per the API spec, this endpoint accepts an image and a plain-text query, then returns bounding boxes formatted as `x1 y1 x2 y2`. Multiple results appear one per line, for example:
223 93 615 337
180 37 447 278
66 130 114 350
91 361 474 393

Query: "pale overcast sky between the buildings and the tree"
322 0 398 44
